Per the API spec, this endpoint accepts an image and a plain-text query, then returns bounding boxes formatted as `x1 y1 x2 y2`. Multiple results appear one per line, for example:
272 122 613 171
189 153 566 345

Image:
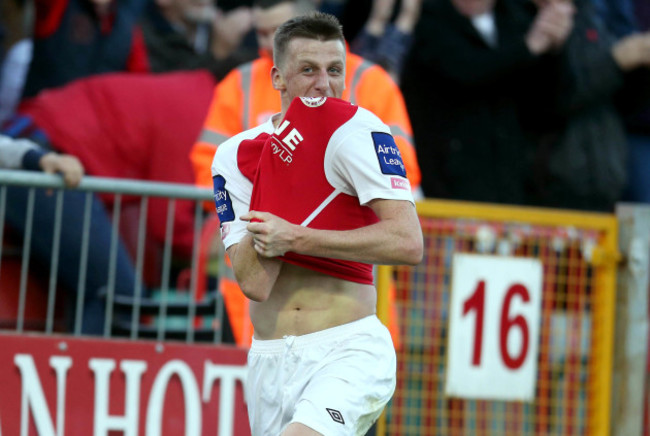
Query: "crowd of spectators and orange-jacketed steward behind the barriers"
0 0 650 333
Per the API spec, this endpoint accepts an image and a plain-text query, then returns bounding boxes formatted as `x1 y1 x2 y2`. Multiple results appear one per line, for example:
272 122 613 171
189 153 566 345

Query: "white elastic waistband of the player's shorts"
250 315 383 354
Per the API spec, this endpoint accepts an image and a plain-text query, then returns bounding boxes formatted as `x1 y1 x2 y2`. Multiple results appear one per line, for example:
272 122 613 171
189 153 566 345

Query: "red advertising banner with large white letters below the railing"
0 334 250 436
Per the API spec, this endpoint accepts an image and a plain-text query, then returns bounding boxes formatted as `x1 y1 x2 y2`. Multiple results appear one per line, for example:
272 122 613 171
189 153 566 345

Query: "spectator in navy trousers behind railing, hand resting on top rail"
0 135 136 335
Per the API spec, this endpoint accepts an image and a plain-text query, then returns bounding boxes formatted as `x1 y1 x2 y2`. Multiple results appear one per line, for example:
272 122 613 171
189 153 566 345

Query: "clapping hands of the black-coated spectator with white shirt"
526 0 575 55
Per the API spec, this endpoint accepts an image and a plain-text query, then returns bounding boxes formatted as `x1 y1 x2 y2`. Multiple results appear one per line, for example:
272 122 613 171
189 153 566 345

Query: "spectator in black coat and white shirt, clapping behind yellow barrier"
402 0 573 204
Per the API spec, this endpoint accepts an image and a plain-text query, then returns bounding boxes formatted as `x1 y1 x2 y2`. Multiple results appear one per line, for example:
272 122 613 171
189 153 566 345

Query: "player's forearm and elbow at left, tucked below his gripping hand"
228 235 281 302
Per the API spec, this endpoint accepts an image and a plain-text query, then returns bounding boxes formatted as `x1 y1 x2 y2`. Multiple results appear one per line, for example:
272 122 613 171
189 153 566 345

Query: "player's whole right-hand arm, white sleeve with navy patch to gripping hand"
242 116 423 265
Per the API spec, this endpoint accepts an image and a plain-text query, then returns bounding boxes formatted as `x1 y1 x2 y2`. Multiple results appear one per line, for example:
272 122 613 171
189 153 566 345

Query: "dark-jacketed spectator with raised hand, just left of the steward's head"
142 0 255 79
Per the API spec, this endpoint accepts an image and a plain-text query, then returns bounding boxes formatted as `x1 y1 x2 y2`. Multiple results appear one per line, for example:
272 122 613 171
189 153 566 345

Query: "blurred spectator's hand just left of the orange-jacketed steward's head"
212 6 253 59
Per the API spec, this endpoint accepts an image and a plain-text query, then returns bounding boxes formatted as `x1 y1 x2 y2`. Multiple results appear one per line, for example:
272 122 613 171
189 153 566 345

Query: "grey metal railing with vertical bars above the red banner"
0 170 224 343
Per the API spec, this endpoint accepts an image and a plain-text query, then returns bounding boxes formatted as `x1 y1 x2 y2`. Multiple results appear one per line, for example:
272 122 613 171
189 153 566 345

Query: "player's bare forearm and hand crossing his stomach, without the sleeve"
242 199 423 265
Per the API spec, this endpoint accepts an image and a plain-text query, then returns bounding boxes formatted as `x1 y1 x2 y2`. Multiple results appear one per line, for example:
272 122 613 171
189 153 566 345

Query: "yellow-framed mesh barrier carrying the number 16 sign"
379 201 618 436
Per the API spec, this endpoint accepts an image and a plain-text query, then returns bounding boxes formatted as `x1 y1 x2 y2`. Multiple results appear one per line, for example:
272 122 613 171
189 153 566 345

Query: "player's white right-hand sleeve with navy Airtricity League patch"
325 108 414 205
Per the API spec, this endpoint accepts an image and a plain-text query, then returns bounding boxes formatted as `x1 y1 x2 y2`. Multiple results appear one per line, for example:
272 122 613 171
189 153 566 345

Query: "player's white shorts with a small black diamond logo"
245 315 397 436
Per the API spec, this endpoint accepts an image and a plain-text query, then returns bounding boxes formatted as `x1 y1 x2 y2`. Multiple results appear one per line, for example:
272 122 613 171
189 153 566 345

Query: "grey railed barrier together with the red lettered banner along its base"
0 171 250 436
